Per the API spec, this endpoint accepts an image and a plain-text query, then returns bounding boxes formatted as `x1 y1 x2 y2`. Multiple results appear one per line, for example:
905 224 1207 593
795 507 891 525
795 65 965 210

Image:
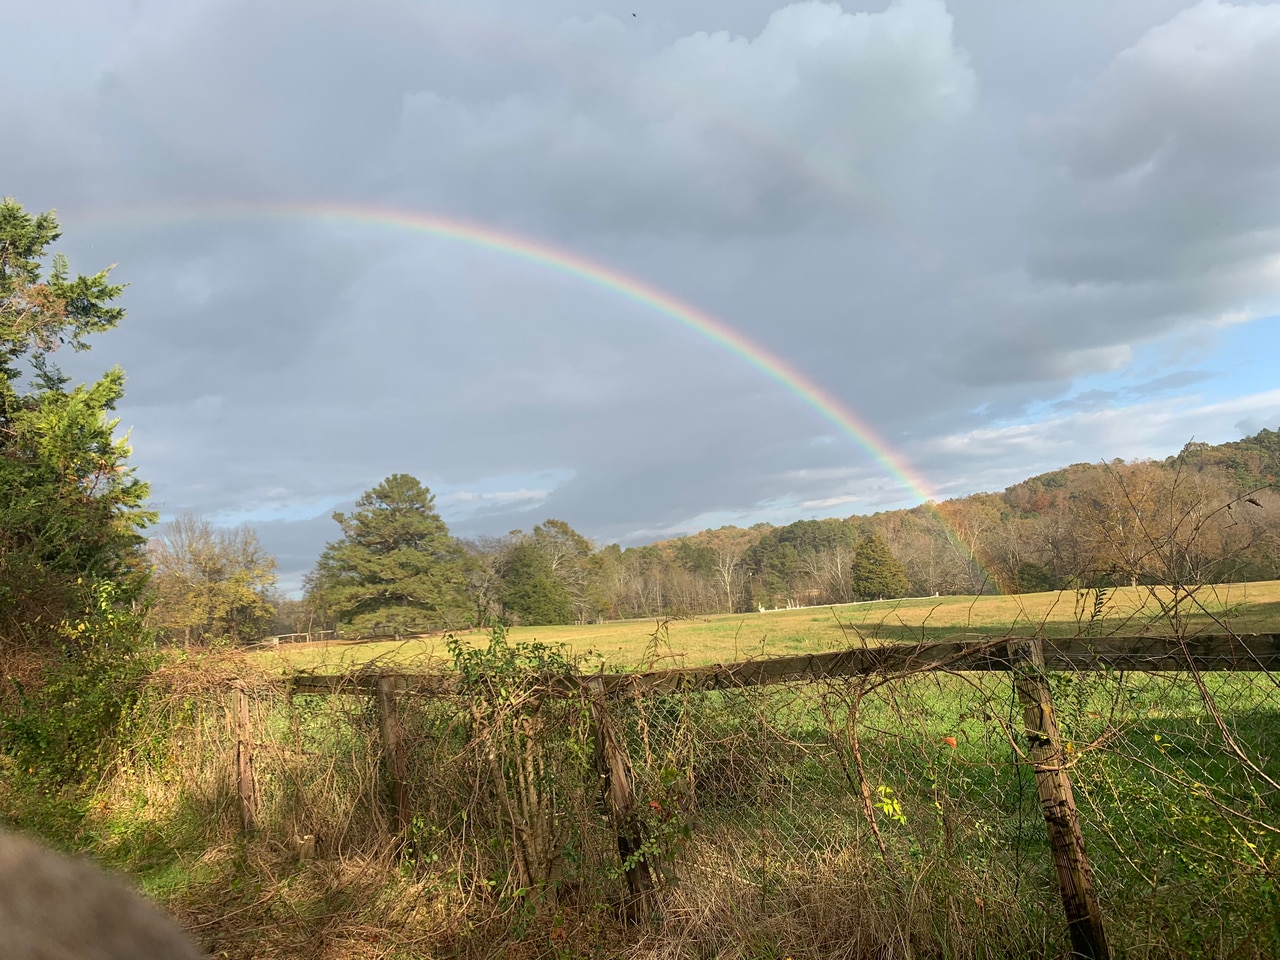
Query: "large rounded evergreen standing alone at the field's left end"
308 474 468 631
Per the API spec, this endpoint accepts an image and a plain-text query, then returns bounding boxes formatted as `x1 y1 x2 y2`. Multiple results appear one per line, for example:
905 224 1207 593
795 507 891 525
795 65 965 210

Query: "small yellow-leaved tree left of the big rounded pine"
148 513 275 644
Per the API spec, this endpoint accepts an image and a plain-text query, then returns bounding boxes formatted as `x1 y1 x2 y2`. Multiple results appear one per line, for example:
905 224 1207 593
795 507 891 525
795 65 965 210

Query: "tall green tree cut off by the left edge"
0 198 155 650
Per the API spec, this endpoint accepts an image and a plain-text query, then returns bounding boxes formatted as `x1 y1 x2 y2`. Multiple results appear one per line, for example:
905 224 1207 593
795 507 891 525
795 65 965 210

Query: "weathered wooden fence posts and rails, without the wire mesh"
234 634 1280 959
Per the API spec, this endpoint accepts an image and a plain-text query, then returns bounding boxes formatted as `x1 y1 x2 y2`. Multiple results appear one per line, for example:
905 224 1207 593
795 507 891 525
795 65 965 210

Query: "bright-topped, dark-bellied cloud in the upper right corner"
1029 0 1280 289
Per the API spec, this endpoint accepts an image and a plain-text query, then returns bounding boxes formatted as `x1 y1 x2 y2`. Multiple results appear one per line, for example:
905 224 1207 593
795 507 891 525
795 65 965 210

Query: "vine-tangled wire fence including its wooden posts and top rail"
140 636 1280 960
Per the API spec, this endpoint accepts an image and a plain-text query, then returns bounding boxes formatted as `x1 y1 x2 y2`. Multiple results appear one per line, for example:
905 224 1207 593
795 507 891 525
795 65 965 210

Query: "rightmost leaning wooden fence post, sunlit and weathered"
1009 639 1111 960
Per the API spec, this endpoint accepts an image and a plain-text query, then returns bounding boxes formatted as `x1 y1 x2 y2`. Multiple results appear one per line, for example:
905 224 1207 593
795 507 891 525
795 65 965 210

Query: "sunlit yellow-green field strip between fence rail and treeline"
252 581 1280 672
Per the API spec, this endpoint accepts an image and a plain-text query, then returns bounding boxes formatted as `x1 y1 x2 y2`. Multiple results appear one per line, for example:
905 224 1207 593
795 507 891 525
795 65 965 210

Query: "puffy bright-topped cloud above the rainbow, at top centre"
387 0 975 233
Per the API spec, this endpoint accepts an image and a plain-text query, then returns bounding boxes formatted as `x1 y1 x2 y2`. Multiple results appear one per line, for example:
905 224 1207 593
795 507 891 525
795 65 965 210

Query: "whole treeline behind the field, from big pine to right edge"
235 430 1280 632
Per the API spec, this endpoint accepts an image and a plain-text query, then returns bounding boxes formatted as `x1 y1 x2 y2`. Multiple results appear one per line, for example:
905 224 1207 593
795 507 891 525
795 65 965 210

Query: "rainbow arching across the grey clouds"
72 201 998 591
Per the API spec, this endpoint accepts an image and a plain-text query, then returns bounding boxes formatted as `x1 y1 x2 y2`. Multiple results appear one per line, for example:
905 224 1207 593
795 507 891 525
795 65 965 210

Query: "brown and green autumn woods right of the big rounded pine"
304 431 1280 632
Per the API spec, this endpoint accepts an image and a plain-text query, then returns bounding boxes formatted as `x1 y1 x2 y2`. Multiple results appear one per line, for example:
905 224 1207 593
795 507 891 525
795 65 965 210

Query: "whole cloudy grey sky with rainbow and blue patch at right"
0 0 1280 590
